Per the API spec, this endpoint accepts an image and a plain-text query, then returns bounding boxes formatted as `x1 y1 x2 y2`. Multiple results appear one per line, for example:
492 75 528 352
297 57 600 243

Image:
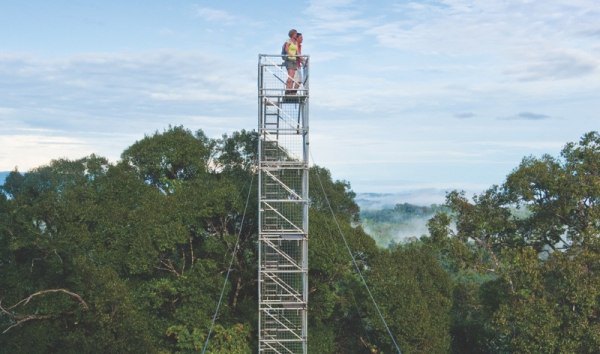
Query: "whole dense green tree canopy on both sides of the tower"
0 127 600 353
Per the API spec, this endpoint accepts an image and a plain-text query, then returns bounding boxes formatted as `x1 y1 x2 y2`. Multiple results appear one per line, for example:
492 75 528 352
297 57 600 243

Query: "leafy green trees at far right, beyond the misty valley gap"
425 132 600 353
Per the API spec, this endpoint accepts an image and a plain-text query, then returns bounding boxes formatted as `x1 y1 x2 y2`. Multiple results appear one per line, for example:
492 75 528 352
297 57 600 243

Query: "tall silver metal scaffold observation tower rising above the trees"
258 54 309 353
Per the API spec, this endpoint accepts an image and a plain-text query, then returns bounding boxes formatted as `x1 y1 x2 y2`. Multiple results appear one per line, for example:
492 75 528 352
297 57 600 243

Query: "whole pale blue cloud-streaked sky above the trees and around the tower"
0 0 600 199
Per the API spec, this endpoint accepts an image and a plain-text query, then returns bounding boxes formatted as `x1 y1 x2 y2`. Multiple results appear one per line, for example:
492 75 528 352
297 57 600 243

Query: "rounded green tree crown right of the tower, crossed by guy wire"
369 243 452 353
